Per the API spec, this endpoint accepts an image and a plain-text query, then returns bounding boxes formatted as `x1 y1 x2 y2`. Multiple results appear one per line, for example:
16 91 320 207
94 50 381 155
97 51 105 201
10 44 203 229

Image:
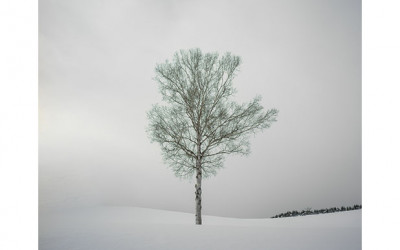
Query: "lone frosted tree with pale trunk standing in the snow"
148 49 278 224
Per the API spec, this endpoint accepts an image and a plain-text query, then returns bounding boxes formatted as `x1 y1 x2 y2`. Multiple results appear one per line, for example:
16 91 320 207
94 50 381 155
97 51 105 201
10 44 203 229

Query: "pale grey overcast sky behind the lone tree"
39 0 361 218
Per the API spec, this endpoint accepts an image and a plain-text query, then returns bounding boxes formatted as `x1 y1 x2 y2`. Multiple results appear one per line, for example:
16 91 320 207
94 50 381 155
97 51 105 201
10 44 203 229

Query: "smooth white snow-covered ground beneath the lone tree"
39 207 361 250
